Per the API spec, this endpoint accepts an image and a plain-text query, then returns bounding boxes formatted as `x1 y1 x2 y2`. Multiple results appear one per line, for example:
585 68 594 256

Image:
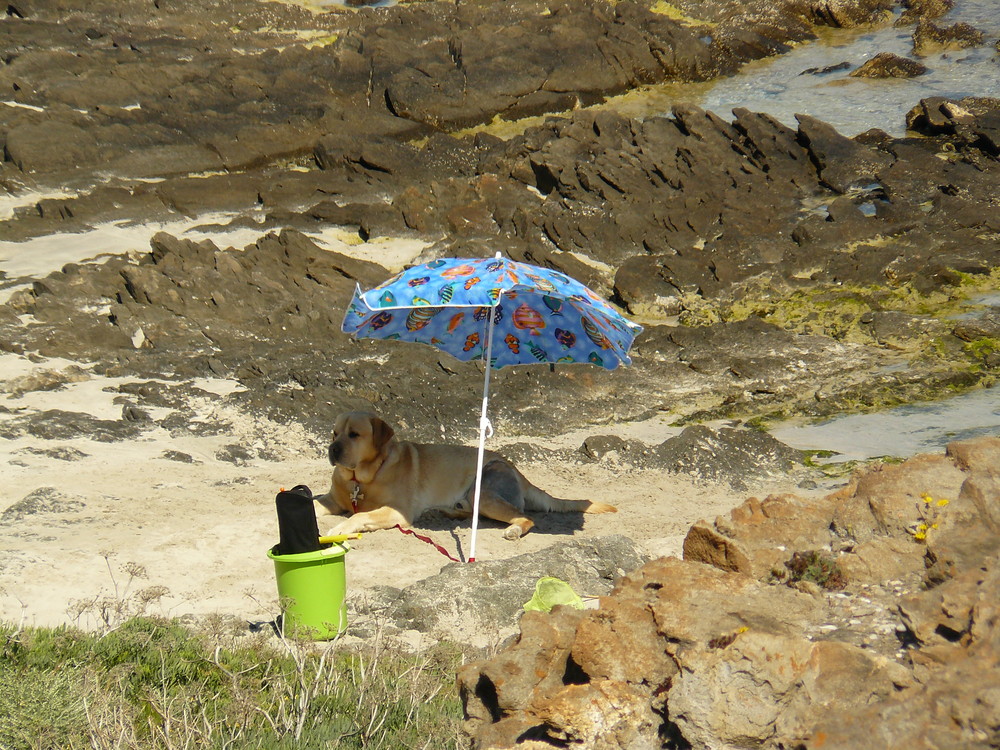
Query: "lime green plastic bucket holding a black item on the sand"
267 543 350 641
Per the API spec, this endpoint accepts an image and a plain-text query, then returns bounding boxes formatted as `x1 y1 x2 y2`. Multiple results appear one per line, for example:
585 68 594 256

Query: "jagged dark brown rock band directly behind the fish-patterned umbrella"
0 99 1000 434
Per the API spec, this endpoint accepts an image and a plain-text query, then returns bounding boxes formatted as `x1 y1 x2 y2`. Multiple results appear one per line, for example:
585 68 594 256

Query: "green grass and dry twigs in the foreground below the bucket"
0 617 461 750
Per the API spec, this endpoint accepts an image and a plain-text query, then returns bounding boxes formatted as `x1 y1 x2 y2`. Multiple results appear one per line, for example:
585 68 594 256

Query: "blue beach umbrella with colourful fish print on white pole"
342 253 642 562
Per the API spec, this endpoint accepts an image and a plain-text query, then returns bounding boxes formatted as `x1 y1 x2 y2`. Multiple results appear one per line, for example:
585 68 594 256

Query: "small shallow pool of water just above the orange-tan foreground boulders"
770 386 1000 463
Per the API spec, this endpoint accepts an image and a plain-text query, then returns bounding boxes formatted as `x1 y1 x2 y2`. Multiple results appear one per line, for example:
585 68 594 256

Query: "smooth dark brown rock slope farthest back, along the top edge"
0 0 887 191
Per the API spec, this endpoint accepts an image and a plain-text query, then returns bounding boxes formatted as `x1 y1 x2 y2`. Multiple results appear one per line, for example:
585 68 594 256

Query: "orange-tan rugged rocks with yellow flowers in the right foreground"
458 438 1000 750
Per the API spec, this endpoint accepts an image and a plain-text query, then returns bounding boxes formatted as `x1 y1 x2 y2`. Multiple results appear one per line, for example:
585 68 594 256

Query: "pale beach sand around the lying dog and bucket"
0 346 820 628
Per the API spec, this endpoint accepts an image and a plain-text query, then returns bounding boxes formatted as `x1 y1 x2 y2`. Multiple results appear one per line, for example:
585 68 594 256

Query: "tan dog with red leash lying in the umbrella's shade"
316 412 617 539
